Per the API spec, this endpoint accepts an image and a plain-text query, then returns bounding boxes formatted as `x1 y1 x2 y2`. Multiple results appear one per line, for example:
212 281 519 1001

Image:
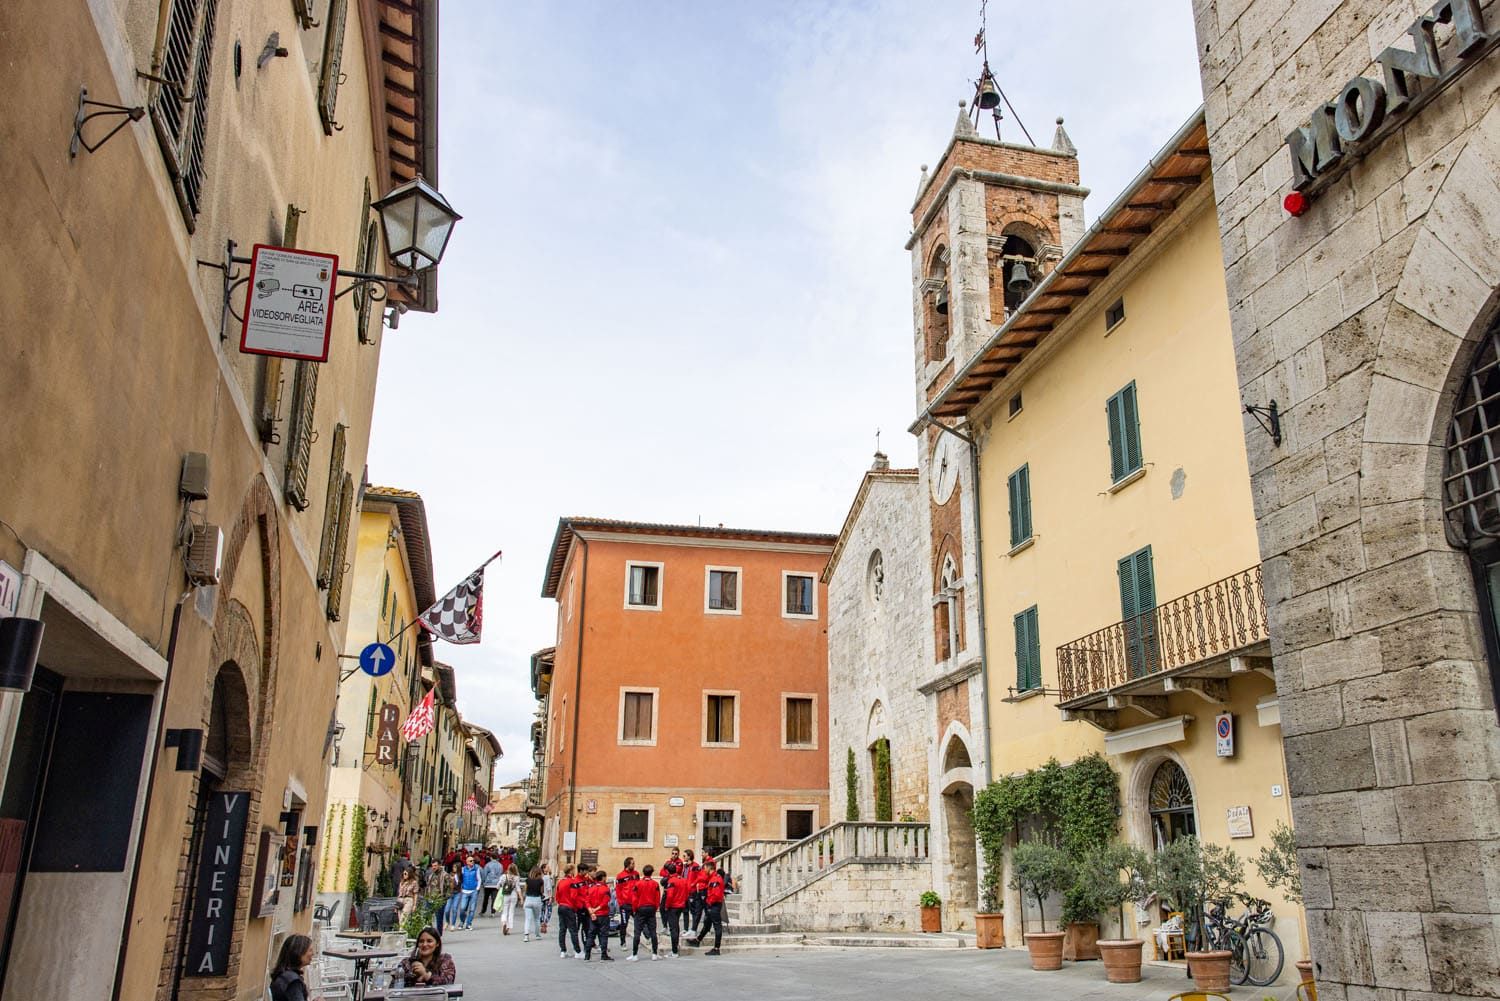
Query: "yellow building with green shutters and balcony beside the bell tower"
926 114 1302 975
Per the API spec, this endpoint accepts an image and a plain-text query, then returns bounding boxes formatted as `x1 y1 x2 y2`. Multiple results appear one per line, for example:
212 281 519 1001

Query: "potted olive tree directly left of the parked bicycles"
1152 836 1245 990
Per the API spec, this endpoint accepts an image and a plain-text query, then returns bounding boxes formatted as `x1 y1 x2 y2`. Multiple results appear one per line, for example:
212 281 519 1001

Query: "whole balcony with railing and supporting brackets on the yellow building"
1058 564 1274 729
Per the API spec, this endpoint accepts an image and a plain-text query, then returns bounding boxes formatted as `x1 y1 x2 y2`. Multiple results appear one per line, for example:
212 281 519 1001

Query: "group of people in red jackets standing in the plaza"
555 848 728 962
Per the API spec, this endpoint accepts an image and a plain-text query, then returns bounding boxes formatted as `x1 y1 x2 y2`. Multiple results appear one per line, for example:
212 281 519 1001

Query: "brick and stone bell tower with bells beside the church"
906 99 1089 912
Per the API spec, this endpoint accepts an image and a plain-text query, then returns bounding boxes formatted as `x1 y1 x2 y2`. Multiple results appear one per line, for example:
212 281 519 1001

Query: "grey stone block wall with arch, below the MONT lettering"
1194 0 1500 1001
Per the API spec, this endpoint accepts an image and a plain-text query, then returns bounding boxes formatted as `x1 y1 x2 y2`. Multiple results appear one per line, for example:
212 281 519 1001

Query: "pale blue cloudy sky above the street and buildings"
369 0 1202 785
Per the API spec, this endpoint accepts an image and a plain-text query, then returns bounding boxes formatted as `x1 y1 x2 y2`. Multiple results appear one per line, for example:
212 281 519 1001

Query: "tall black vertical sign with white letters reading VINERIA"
183 791 251 977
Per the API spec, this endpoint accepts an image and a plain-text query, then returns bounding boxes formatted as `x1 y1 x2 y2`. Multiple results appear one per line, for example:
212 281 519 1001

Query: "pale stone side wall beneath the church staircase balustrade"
764 861 933 932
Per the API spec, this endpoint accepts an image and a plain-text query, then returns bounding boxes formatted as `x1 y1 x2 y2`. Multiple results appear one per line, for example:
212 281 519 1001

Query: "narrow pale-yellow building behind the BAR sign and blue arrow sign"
318 486 434 914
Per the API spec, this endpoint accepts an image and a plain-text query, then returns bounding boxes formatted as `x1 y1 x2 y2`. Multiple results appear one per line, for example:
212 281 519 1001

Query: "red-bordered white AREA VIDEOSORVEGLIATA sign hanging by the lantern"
240 243 339 362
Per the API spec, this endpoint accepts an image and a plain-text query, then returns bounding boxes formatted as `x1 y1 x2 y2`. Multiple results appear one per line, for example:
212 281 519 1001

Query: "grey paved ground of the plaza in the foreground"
444 917 1230 1001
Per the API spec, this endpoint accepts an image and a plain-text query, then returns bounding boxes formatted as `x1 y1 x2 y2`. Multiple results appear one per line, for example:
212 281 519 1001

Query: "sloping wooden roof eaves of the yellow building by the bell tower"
909 105 1206 434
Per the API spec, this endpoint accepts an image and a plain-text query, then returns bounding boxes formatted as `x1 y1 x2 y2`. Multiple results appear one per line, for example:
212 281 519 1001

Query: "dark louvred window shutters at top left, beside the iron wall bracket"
152 0 219 225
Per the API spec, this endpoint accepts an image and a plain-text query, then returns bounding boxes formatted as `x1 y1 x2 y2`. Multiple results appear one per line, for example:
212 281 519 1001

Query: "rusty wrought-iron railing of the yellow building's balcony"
1058 563 1271 704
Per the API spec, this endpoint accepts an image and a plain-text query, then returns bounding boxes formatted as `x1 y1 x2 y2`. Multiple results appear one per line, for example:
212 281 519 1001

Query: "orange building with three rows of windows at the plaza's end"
539 518 834 870
